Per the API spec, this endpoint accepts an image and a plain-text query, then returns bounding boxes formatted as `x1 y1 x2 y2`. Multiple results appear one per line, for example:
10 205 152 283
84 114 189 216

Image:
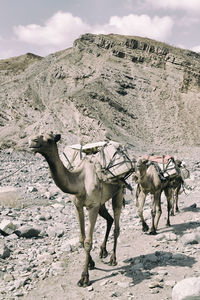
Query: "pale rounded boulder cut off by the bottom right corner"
172 277 200 300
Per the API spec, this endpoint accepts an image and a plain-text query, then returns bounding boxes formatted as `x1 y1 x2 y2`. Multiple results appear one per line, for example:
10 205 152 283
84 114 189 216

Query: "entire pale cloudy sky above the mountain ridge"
0 0 200 59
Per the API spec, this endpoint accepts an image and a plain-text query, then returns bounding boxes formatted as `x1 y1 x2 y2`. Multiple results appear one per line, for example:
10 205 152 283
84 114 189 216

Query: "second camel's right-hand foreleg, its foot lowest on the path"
150 191 162 234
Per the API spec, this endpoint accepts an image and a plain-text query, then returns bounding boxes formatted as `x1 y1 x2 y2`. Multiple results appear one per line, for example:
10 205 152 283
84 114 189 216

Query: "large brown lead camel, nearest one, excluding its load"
29 133 124 287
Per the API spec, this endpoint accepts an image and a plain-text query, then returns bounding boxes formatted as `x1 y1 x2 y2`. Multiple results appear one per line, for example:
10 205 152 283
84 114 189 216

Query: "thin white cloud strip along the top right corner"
145 0 200 13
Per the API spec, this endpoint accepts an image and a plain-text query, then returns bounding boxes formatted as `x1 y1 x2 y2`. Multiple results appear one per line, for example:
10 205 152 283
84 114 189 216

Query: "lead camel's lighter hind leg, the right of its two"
110 189 123 266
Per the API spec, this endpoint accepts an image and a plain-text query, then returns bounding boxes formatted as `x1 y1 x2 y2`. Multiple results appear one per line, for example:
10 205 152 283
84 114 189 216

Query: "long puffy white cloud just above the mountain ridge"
11 12 173 55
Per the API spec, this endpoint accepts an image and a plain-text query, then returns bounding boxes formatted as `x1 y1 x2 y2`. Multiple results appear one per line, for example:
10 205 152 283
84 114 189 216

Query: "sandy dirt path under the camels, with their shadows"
21 191 200 300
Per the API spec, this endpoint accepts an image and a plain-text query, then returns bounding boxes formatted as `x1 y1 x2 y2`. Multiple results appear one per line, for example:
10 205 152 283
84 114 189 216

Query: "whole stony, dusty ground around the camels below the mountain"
0 150 200 300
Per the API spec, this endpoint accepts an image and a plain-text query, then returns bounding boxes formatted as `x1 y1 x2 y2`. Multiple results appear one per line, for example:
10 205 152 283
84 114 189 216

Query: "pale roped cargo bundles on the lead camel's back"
63 141 136 189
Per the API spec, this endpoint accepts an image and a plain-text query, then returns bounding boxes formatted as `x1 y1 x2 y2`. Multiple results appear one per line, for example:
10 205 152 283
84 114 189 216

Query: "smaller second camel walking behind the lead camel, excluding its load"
136 158 182 234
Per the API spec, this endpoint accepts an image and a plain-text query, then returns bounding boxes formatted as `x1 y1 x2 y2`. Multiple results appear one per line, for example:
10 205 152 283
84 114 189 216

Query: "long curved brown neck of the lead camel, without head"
43 149 82 194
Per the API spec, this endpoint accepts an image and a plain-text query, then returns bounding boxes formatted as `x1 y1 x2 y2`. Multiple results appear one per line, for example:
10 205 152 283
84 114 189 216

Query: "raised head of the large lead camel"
29 133 61 155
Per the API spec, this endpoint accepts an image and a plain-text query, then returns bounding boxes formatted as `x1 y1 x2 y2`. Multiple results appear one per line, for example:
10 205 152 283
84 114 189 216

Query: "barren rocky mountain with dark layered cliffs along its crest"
0 34 200 151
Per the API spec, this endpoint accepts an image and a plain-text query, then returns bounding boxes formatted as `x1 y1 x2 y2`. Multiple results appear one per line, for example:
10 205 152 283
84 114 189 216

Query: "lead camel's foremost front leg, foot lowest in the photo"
78 206 99 287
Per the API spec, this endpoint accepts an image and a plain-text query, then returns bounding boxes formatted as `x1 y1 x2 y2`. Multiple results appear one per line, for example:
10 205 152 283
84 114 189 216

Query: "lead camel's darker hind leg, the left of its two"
99 204 113 258
